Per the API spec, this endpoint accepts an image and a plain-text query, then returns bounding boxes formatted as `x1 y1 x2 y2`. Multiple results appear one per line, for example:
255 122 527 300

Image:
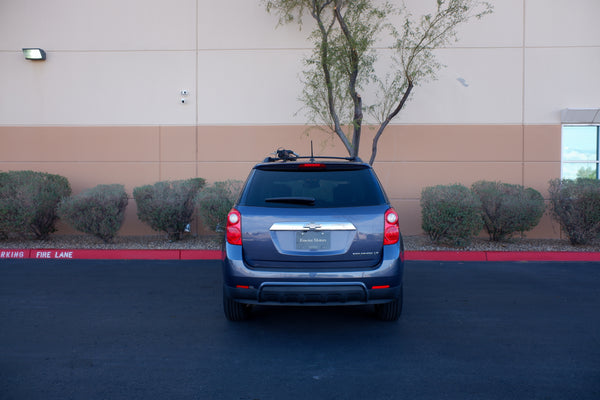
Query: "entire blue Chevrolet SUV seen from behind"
223 150 404 321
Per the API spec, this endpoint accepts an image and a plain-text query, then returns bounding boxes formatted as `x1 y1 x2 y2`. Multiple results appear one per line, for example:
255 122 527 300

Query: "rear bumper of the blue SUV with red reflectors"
223 244 404 305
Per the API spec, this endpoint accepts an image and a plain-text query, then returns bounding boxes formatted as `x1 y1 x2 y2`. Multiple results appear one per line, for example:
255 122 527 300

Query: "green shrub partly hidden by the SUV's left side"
196 180 244 232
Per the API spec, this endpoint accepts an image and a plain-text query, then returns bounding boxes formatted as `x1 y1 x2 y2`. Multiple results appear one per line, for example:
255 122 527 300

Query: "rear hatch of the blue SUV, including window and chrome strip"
237 163 389 270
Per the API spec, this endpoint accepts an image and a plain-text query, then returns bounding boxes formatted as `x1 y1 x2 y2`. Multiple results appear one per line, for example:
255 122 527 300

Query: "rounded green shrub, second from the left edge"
58 184 129 243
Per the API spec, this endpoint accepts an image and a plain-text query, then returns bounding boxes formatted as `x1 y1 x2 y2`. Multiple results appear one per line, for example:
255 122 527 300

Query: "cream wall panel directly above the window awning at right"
525 47 600 124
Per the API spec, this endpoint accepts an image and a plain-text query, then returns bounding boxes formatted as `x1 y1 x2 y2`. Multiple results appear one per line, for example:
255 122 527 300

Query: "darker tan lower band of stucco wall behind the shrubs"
0 125 560 237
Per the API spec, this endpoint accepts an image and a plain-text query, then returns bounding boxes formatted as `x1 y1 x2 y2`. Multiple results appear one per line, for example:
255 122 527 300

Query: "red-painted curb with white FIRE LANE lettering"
0 249 600 262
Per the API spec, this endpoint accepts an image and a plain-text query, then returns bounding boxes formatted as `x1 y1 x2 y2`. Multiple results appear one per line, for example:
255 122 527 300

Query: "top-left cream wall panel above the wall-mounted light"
0 0 196 51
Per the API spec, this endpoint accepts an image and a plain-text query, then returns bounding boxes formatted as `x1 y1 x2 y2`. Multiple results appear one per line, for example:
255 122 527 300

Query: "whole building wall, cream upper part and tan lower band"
0 0 600 237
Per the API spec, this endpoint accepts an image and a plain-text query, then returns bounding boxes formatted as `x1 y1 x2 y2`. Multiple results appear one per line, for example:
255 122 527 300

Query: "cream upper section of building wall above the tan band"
0 0 600 125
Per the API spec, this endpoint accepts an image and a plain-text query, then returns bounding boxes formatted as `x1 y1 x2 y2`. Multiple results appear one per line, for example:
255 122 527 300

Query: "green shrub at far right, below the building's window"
549 178 600 245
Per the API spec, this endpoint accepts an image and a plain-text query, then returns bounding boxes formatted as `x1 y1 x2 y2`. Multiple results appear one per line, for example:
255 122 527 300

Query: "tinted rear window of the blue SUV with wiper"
240 168 386 208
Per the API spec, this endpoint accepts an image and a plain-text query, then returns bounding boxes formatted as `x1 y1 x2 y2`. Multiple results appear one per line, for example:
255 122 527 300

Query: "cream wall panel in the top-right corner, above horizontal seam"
525 0 600 47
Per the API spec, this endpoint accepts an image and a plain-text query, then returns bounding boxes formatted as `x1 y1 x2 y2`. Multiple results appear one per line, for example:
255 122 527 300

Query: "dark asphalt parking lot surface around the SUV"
0 260 600 400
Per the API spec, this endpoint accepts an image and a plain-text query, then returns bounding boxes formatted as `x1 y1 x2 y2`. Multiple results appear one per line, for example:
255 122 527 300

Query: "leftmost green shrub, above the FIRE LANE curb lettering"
0 171 71 240
